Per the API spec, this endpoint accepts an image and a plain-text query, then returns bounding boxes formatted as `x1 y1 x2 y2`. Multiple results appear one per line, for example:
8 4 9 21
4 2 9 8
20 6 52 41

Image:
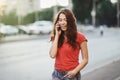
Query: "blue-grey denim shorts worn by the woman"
52 69 81 80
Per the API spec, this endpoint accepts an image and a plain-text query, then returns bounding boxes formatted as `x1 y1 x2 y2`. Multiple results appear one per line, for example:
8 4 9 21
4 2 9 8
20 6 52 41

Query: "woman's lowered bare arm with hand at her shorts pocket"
65 41 88 78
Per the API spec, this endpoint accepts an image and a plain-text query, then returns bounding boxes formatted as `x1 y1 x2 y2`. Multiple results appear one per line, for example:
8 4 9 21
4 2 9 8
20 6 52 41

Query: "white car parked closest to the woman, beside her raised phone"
28 21 53 34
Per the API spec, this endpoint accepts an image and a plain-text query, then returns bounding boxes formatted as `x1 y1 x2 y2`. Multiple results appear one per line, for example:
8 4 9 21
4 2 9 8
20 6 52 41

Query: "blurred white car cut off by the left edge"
0 25 19 35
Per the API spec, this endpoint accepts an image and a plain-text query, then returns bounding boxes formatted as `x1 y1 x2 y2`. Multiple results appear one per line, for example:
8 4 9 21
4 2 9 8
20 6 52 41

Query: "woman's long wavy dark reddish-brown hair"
51 9 77 49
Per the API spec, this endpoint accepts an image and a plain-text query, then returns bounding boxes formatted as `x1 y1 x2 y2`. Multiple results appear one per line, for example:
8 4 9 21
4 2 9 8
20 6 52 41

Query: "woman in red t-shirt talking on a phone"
49 9 88 80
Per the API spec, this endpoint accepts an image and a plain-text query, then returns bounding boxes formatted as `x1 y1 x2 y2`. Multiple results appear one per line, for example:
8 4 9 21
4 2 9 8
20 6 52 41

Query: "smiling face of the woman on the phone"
58 13 67 31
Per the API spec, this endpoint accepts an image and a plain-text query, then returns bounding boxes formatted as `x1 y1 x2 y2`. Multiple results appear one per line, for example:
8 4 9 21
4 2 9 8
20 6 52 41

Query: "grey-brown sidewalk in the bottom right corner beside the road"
81 60 120 80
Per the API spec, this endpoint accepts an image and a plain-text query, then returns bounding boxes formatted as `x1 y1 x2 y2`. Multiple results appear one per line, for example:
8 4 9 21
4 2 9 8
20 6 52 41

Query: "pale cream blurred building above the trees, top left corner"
1 0 40 16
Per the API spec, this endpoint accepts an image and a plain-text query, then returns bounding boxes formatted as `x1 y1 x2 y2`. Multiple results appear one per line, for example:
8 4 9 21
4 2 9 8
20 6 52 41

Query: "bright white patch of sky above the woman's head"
40 0 69 8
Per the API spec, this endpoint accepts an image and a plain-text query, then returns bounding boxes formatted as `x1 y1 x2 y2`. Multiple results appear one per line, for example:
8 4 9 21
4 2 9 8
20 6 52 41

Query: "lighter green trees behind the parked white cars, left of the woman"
0 6 63 25
